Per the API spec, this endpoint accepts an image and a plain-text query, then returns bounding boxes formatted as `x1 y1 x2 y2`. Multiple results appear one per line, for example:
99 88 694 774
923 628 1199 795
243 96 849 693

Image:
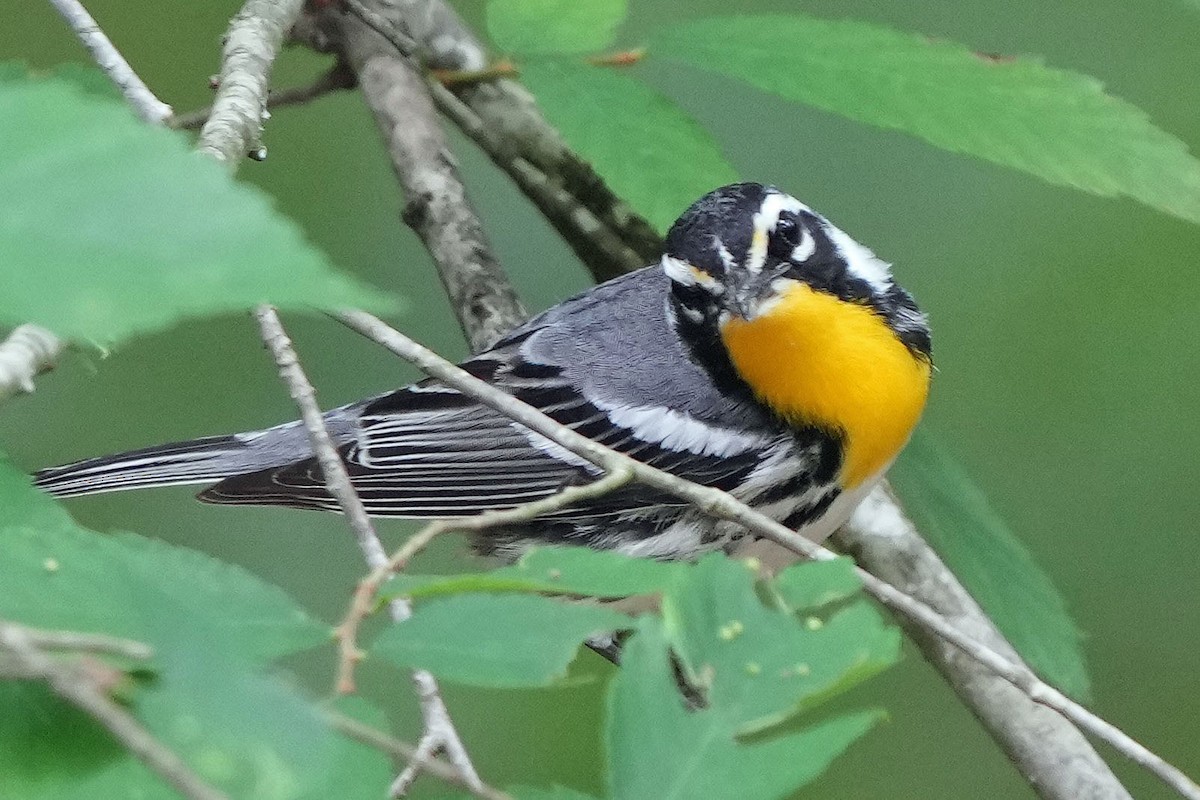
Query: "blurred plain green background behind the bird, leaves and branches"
0 0 1200 798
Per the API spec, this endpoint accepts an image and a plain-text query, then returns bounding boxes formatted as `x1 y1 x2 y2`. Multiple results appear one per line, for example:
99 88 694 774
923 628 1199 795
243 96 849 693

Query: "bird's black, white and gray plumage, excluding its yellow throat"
36 184 929 558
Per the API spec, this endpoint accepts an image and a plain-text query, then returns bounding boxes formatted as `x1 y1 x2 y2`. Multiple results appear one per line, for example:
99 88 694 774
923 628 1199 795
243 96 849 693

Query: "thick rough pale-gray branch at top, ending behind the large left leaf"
197 0 304 167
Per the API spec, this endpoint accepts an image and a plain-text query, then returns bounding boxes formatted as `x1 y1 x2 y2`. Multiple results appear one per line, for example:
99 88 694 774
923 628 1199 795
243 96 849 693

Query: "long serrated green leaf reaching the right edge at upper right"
652 14 1200 222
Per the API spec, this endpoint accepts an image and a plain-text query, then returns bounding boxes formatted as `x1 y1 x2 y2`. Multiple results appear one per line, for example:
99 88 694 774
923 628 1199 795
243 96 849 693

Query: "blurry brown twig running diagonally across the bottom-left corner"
0 620 227 800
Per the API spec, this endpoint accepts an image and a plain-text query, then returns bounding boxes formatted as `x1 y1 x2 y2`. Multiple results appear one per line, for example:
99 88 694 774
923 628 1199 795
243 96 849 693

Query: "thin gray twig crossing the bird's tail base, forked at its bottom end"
254 306 482 792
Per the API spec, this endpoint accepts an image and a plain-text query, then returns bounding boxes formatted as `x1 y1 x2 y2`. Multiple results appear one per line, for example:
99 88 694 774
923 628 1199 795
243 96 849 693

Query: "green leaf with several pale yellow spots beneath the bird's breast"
662 555 900 734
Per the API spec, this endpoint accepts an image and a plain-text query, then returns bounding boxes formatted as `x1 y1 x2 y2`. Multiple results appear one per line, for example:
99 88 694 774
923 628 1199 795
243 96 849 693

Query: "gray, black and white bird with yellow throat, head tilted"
35 182 932 560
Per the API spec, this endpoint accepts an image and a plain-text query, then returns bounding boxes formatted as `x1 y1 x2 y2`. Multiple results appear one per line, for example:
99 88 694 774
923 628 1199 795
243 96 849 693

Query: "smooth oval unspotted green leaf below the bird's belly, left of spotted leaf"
372 595 631 687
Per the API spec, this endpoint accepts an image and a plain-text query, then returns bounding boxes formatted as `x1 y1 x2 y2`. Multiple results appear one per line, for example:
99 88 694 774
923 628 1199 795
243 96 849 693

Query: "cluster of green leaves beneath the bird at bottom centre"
372 547 900 798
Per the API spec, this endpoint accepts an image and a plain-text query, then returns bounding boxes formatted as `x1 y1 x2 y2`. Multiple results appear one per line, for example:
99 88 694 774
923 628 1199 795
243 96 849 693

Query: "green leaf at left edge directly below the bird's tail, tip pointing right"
0 457 330 662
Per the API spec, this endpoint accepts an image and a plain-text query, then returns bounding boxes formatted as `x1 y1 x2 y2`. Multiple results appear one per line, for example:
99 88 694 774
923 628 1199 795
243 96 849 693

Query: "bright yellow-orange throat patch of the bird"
721 281 930 489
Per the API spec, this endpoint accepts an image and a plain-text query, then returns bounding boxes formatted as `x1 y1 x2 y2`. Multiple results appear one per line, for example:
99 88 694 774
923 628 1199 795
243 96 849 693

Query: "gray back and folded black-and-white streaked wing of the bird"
200 270 780 517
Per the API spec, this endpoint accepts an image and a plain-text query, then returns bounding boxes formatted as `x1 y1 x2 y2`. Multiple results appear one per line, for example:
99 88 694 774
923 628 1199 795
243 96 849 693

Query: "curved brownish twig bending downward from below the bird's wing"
336 469 634 691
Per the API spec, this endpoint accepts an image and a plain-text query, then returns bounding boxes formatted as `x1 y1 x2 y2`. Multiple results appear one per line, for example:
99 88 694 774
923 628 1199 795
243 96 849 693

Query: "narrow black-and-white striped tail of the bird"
34 435 250 498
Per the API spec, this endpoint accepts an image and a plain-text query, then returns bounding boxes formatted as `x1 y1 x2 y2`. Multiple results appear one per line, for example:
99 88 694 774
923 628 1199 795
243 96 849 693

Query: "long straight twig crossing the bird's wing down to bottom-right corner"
337 311 1200 800
